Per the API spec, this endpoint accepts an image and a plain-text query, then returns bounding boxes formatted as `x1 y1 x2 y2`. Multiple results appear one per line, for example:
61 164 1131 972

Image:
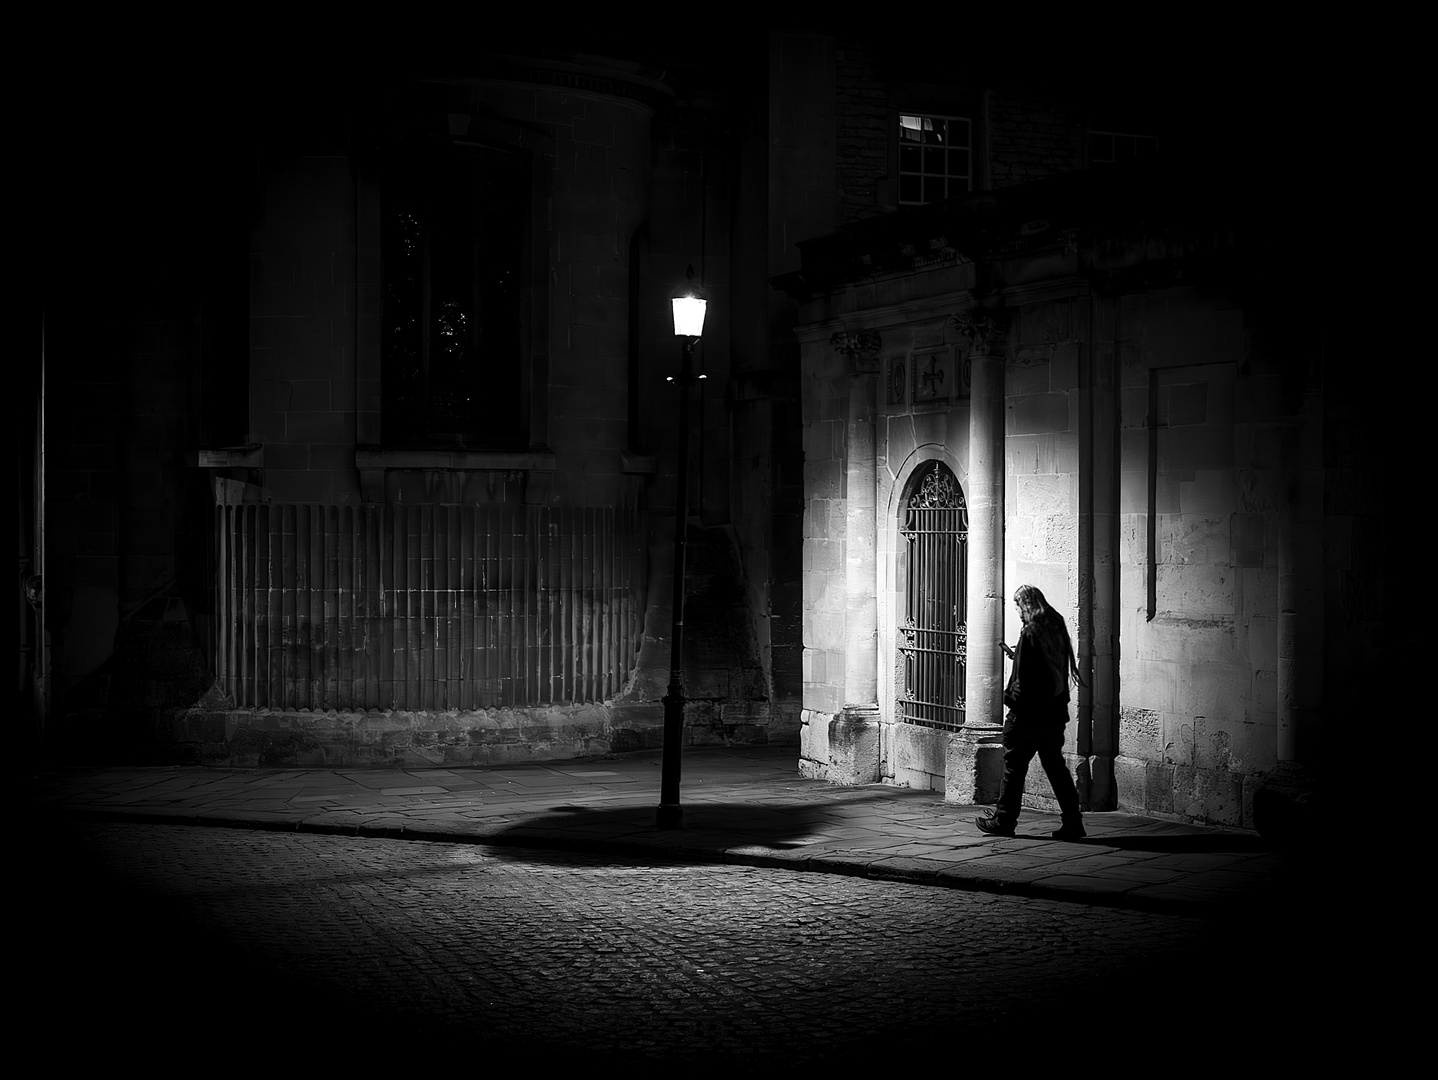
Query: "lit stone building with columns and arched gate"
782 153 1357 825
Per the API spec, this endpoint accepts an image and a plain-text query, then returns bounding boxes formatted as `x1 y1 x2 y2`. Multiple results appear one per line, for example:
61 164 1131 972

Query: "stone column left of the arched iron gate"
828 331 881 784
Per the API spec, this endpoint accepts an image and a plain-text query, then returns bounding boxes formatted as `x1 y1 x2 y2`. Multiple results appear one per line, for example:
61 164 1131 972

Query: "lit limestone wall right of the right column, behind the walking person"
1005 288 1299 825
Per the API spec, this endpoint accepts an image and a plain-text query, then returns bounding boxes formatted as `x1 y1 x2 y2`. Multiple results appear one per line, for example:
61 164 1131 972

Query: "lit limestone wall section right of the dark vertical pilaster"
1113 289 1299 825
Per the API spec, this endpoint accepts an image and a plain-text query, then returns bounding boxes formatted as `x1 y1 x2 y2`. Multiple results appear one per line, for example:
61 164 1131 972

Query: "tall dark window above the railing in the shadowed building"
383 138 529 449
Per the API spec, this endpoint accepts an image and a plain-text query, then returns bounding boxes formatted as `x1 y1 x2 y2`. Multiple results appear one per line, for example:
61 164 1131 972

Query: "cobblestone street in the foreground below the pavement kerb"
30 824 1345 1066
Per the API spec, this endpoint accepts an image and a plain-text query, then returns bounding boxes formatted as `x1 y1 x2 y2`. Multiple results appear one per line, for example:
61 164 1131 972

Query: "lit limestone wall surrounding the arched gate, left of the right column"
801 267 971 791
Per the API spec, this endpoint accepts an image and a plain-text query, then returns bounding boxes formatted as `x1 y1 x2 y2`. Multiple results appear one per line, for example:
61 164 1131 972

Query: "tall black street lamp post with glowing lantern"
656 293 706 828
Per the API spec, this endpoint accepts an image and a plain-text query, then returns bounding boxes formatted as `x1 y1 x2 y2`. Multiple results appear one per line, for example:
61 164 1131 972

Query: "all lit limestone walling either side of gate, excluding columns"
802 264 1323 825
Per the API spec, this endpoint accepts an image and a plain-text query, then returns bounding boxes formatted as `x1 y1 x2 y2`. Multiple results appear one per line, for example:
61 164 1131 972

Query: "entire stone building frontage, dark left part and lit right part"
22 29 1363 824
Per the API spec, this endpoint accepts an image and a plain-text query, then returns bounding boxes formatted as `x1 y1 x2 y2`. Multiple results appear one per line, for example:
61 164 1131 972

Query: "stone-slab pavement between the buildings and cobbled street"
32 746 1300 915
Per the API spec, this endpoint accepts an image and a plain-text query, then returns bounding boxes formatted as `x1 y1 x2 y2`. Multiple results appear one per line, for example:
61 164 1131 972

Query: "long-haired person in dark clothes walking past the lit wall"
975 585 1084 840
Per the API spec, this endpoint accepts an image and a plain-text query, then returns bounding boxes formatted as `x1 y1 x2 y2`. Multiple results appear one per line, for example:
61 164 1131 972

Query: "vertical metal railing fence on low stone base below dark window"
216 505 646 710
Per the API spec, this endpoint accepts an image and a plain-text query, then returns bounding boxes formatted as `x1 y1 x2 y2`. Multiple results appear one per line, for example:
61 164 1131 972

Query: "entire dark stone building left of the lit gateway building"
33 44 798 764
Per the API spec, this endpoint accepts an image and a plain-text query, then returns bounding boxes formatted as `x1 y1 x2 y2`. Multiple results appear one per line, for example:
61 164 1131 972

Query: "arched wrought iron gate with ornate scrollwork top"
897 462 969 731
